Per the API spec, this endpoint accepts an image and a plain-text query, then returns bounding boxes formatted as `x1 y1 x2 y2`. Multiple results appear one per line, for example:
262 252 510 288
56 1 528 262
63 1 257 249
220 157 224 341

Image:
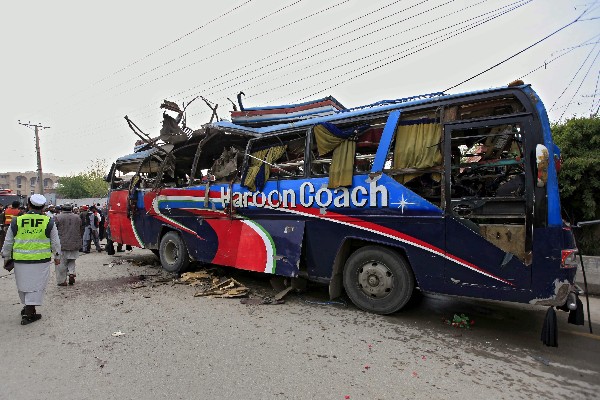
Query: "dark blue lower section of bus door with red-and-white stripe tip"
445 217 531 302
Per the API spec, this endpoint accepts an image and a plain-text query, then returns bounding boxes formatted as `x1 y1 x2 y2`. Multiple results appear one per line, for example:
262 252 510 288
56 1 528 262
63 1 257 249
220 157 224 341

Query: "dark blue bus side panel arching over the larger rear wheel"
306 215 445 292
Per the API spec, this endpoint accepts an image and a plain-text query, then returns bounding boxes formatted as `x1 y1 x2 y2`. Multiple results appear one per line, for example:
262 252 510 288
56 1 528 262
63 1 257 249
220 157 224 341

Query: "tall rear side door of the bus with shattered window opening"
443 116 535 299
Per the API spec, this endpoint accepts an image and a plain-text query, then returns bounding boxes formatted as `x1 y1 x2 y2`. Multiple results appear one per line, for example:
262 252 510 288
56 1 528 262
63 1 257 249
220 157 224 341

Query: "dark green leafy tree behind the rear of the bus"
552 117 600 255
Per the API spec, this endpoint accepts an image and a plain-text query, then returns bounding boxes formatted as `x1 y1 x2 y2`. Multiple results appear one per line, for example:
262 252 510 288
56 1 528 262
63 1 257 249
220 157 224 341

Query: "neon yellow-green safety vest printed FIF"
13 214 52 263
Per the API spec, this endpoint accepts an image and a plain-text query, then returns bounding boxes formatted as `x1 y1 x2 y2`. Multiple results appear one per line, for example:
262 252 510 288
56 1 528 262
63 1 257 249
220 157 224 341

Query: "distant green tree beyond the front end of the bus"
56 160 108 199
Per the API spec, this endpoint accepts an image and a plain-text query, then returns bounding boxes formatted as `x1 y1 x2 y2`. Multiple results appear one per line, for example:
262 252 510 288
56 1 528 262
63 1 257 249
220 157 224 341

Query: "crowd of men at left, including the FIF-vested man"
0 194 105 325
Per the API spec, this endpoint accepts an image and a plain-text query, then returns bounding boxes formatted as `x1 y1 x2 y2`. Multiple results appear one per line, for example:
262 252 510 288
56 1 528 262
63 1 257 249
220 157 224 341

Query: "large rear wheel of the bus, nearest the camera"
344 246 415 314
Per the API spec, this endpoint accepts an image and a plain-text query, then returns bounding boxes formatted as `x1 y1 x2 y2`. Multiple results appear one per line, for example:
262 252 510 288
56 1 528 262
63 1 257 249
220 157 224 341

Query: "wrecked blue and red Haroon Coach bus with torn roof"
109 83 579 332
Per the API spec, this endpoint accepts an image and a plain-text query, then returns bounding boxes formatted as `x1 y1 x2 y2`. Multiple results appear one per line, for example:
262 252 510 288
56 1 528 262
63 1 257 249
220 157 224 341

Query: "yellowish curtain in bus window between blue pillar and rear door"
394 121 442 184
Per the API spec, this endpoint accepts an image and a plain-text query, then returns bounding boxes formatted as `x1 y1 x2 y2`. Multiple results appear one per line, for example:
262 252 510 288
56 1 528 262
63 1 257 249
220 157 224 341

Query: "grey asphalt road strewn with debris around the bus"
0 250 600 400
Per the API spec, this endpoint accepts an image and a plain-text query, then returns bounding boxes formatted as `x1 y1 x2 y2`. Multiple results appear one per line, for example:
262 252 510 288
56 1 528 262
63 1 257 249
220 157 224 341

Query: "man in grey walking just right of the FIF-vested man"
54 204 81 286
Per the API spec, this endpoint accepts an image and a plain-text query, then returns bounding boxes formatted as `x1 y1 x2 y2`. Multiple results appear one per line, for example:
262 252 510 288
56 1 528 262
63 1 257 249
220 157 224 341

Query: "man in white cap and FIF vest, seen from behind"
2 194 60 325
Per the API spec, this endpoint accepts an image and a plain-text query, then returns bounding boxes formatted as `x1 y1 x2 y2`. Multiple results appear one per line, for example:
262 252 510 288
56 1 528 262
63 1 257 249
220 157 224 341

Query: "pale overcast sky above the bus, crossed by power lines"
0 0 600 176
